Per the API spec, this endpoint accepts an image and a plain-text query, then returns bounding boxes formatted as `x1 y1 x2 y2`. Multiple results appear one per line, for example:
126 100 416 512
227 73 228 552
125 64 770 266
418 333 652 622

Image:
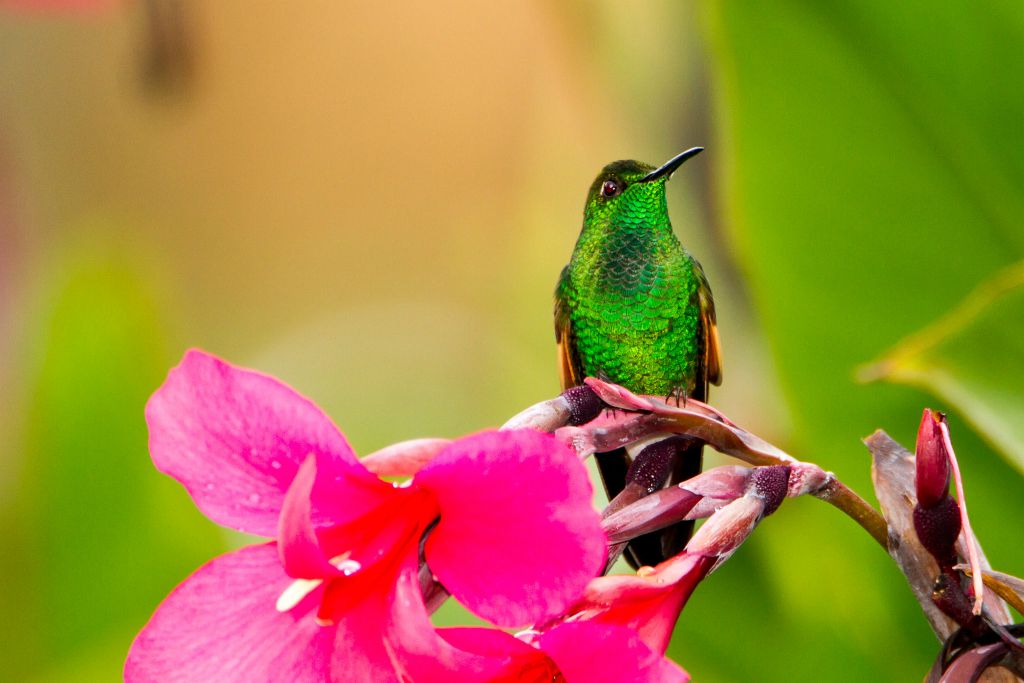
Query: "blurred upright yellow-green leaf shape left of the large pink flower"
7 254 222 681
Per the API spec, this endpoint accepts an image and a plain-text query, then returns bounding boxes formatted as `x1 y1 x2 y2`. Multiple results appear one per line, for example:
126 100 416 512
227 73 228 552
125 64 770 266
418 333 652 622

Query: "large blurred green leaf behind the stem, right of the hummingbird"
704 0 1024 680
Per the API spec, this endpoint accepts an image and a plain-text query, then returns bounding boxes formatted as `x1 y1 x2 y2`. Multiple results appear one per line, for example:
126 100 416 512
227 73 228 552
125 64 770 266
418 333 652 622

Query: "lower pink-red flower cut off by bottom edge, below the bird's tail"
376 554 714 683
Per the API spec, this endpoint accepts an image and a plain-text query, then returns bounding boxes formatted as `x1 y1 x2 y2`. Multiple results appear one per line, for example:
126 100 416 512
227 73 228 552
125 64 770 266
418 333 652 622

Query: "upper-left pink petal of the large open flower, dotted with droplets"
145 350 377 537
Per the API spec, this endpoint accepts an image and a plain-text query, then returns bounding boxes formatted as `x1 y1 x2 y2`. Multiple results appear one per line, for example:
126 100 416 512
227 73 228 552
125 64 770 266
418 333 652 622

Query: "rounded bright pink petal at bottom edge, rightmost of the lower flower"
539 622 690 683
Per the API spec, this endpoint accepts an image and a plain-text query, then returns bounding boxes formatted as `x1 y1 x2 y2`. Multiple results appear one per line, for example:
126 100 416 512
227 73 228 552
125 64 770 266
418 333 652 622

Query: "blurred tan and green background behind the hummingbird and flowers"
0 0 1024 682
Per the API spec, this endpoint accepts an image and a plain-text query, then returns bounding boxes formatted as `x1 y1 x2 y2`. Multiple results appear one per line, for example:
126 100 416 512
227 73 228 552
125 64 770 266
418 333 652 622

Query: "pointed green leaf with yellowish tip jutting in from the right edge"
863 263 1024 481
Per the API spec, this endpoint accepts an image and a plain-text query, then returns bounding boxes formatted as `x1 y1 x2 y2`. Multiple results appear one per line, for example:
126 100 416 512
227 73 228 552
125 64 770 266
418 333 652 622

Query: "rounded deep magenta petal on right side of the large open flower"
415 430 606 626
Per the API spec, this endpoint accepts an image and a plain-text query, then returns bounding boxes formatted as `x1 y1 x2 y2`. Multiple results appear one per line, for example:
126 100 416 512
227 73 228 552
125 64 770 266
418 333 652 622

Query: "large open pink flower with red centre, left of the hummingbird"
125 351 605 683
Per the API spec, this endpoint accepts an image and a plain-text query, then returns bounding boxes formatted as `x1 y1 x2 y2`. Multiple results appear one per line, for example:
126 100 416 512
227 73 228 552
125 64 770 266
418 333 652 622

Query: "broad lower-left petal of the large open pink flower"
125 544 331 683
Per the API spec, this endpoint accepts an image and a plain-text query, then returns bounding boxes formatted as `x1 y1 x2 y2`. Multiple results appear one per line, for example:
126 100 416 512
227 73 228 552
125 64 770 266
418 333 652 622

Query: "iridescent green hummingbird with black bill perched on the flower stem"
554 147 722 568
